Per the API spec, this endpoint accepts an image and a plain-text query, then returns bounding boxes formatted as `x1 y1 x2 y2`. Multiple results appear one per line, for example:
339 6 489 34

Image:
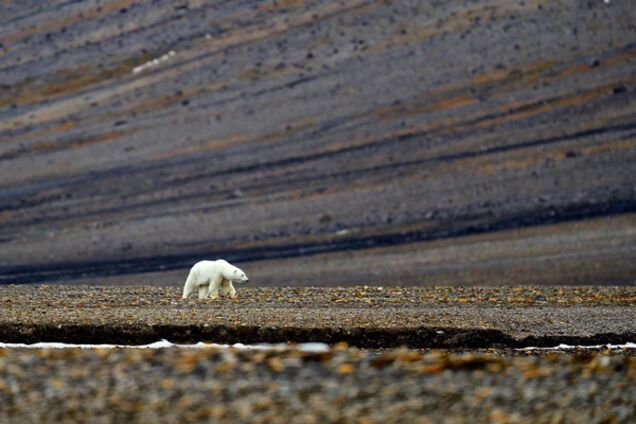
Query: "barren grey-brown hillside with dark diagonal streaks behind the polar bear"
0 0 636 285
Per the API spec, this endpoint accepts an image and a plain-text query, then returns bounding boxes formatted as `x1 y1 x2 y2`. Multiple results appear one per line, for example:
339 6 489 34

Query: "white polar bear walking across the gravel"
183 259 249 299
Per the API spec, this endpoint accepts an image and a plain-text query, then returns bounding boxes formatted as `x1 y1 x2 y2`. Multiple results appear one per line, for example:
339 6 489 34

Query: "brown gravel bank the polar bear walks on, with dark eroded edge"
0 285 636 348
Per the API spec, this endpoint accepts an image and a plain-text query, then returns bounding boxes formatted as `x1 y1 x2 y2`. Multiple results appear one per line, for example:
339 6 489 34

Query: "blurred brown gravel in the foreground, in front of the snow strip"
0 347 636 423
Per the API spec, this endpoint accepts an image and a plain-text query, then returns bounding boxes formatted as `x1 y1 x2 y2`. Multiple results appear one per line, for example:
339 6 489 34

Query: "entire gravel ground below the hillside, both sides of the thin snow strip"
0 285 636 423
